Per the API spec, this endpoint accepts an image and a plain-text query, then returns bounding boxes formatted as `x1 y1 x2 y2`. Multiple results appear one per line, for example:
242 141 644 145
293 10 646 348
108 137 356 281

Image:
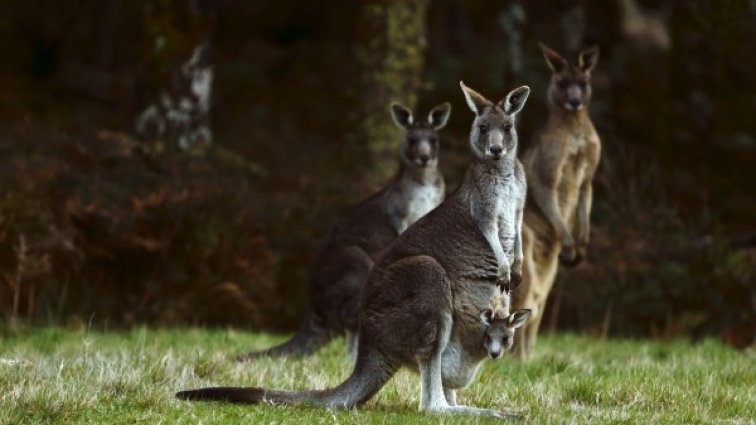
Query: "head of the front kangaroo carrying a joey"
459 81 530 161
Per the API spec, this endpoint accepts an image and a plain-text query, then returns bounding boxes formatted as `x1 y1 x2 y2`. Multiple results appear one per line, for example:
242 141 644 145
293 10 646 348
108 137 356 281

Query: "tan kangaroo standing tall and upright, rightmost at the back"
513 44 601 359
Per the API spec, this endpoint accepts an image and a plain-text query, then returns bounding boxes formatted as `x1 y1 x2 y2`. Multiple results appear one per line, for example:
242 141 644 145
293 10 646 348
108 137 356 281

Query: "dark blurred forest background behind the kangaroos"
0 0 756 346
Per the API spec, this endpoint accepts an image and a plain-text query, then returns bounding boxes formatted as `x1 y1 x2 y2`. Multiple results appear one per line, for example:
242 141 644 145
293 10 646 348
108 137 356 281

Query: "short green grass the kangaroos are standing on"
0 327 756 425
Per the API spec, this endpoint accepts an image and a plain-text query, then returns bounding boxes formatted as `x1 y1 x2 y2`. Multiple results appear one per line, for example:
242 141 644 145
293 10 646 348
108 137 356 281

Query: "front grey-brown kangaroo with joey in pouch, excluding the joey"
176 83 530 417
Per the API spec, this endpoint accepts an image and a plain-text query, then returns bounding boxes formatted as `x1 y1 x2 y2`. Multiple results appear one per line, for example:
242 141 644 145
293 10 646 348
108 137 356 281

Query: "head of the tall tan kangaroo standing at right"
540 43 599 112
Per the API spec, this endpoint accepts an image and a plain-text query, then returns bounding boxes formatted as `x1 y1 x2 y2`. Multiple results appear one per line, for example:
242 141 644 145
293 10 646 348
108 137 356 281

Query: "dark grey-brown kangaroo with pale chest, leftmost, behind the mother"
237 102 451 361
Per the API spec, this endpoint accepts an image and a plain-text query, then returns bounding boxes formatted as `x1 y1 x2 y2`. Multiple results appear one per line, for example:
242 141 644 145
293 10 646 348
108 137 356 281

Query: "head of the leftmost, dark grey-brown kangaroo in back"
391 102 451 168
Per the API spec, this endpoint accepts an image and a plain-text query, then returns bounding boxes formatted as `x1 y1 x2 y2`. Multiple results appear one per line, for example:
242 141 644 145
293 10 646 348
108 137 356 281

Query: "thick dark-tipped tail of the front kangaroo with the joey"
176 347 398 409
